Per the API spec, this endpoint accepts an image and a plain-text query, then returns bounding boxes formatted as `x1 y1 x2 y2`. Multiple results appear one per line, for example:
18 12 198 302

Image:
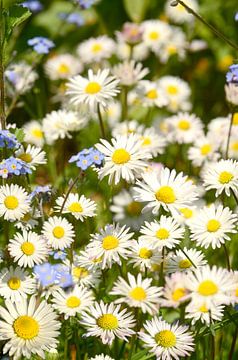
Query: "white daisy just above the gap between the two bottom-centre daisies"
110 273 162 315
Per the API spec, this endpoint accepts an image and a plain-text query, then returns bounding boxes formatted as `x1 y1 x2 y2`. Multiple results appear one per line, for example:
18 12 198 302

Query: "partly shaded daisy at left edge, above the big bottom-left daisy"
0 266 36 302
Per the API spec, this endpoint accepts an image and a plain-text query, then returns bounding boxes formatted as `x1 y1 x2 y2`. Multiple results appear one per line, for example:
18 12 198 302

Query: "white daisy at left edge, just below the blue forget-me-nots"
0 184 30 221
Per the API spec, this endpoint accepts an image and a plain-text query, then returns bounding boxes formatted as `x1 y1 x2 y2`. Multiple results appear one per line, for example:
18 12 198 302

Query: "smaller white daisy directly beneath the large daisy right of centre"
139 215 185 250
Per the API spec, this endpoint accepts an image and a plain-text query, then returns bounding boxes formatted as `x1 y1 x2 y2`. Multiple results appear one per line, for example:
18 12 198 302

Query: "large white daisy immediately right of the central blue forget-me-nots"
95 134 151 185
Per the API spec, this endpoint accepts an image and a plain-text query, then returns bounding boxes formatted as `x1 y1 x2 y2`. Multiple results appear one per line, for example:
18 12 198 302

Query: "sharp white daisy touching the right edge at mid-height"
203 159 238 196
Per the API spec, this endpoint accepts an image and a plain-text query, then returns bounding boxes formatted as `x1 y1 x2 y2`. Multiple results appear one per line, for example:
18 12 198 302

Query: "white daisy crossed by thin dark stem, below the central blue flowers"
55 193 96 221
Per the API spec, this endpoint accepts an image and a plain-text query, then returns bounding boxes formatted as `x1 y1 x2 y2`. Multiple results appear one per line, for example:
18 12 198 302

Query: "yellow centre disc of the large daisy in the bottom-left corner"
13 315 39 340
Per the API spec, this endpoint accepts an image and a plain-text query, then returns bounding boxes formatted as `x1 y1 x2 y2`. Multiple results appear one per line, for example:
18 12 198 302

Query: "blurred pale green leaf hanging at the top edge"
123 0 150 22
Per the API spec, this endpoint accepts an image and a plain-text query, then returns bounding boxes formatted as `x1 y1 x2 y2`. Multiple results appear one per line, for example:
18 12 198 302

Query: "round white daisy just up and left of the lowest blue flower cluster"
8 230 49 267
